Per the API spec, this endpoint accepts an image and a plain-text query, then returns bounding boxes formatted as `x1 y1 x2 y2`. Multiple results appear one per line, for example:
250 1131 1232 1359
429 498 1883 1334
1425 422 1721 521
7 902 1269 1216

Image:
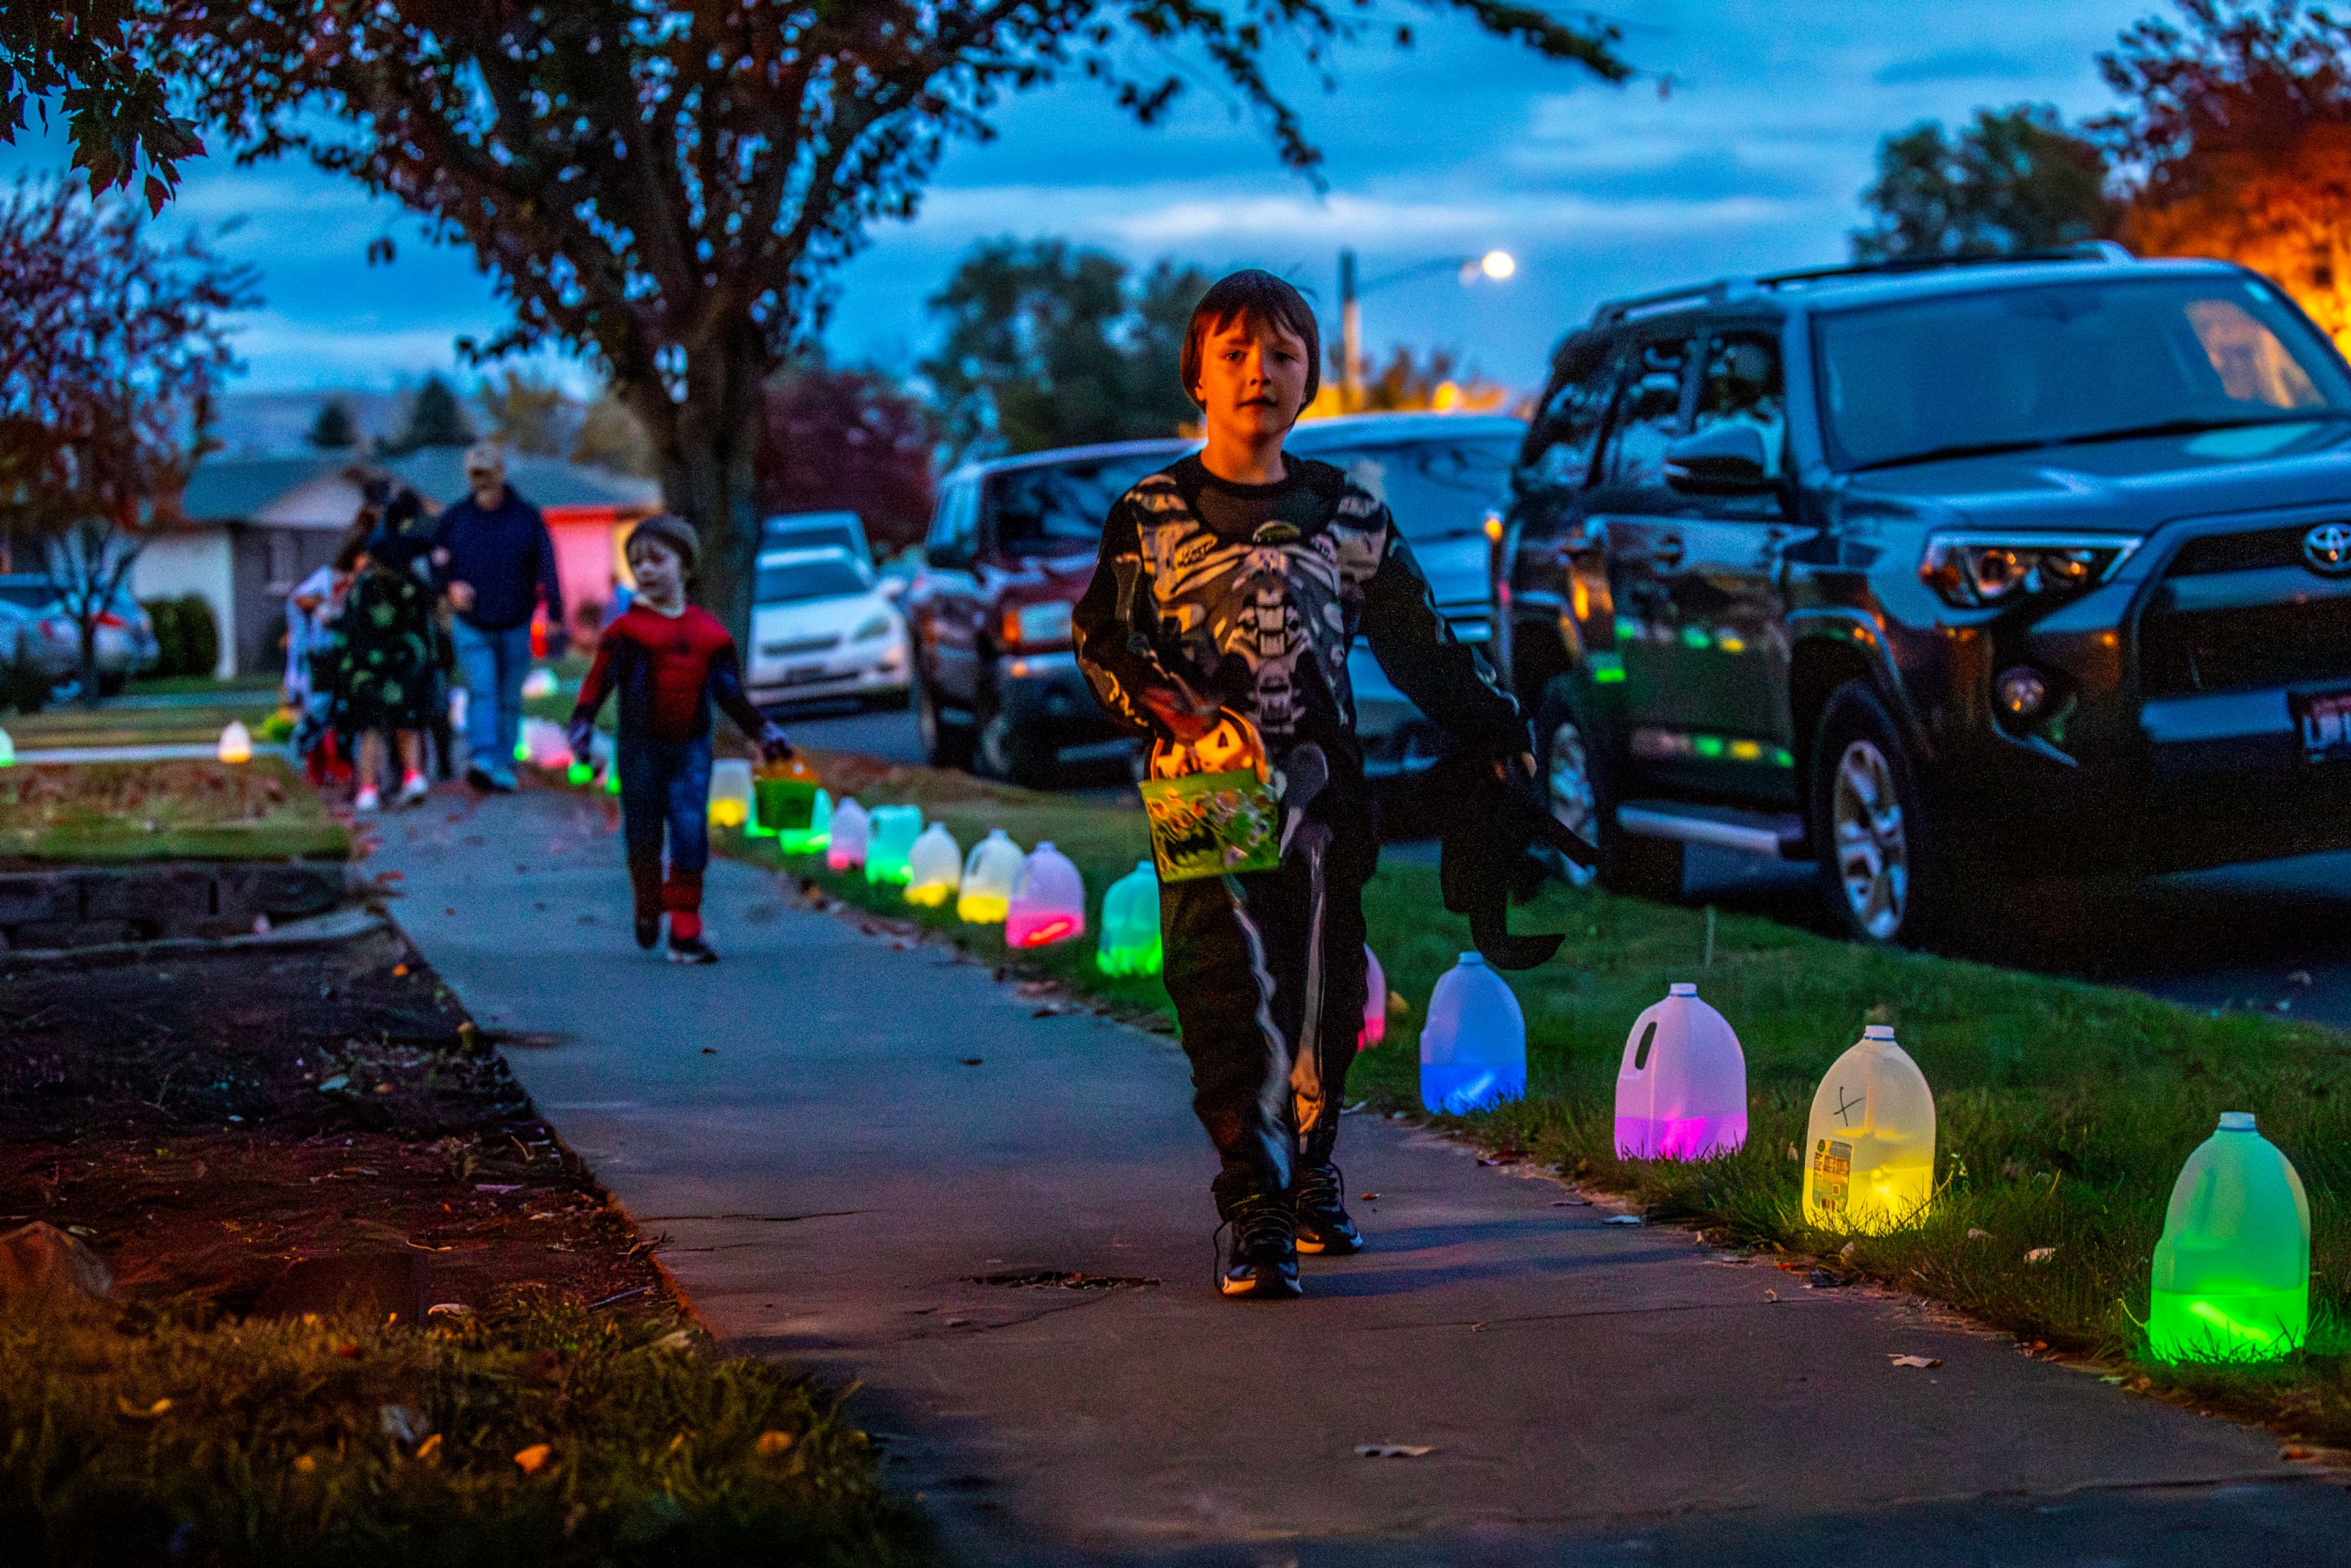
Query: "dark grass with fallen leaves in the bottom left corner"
0 1302 924 1566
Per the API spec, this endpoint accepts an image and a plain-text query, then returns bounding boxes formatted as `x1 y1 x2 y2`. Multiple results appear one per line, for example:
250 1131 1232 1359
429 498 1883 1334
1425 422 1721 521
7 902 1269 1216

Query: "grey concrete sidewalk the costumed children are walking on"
376 790 2351 1568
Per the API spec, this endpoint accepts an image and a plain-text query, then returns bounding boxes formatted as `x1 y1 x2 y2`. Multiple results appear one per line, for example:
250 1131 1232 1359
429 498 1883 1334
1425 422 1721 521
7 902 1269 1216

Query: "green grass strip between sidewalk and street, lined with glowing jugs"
717 755 2351 1444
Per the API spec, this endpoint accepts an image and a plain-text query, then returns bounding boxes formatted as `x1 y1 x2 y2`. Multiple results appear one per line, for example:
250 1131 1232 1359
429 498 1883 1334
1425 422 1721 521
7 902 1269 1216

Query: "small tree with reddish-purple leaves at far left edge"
0 173 258 703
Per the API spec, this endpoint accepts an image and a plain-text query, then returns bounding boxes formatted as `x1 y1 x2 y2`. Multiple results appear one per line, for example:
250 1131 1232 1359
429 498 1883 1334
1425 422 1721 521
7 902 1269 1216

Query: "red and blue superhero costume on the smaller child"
571 602 786 943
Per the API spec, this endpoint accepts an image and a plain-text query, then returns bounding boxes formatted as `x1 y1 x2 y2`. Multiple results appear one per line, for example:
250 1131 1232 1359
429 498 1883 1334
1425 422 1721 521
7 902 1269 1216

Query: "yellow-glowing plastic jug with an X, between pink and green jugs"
1803 1022 1935 1234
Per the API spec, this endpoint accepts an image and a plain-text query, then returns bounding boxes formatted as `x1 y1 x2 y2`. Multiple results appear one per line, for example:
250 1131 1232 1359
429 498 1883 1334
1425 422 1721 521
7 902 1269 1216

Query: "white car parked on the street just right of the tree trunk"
743 546 907 708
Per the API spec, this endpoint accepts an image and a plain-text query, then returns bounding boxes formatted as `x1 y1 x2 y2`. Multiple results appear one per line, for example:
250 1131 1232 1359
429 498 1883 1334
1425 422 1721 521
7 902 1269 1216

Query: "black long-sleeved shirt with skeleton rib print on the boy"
1074 456 1526 764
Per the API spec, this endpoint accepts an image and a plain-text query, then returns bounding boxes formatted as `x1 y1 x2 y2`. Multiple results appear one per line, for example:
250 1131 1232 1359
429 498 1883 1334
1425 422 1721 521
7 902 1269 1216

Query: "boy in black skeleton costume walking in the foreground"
1074 271 1533 1297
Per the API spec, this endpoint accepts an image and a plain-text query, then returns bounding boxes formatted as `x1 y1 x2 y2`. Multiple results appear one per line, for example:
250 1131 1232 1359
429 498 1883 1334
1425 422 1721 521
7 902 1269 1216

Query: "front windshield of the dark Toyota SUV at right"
1813 277 2351 468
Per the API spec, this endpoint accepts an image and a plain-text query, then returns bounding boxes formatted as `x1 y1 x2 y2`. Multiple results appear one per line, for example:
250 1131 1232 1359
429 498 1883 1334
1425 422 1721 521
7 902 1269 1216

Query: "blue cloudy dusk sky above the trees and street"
0 0 2161 404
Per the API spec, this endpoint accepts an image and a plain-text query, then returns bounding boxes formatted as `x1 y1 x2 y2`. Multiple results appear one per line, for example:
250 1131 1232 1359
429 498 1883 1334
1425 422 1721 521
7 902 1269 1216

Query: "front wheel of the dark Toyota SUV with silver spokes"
1813 681 1951 945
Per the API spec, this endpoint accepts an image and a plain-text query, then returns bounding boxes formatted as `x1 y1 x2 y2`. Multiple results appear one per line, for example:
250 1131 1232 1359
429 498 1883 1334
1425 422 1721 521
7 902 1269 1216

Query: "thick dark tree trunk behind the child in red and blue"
632 334 764 663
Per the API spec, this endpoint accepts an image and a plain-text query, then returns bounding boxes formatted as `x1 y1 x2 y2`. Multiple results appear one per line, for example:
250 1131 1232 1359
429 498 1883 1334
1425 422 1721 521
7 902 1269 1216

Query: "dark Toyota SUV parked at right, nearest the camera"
1500 244 2351 943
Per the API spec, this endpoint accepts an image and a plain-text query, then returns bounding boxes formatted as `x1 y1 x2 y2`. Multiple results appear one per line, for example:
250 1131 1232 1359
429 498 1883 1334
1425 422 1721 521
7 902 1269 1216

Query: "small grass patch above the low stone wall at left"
0 752 350 863
